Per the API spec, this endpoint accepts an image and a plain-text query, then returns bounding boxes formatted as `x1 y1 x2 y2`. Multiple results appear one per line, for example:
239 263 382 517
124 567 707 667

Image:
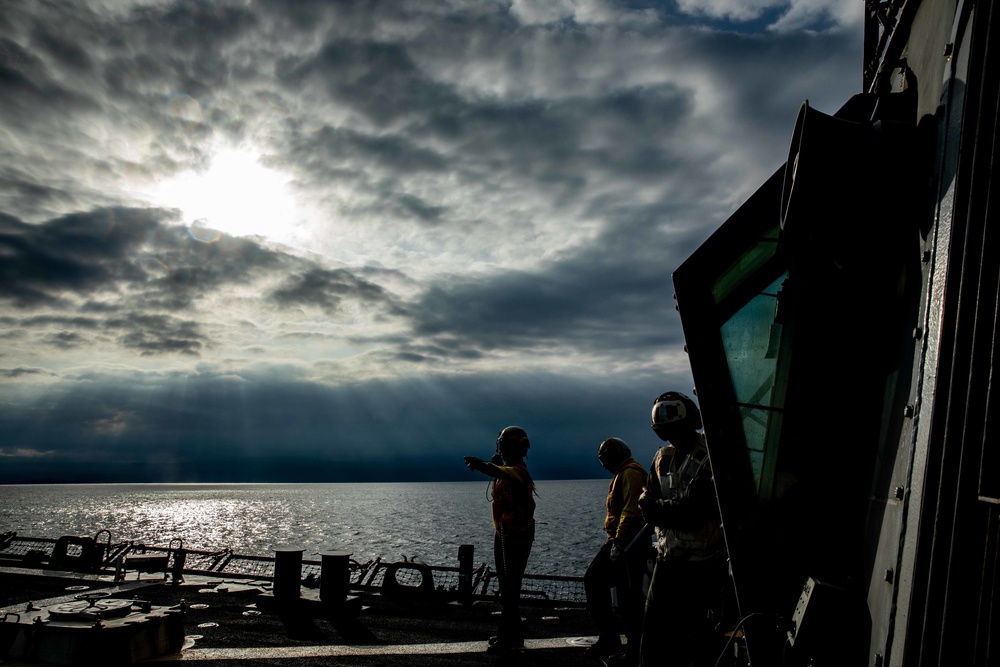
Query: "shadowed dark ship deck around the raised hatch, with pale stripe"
0 568 601 667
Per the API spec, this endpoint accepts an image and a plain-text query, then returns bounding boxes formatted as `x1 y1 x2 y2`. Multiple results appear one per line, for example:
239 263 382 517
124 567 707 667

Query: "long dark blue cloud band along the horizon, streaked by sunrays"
0 374 688 482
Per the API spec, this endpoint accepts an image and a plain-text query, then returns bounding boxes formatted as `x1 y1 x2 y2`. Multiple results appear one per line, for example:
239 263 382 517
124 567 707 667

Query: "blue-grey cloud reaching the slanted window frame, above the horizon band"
410 214 701 359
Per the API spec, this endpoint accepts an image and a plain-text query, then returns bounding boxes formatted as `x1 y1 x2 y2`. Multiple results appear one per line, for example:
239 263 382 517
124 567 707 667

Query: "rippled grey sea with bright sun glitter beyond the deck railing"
0 478 609 576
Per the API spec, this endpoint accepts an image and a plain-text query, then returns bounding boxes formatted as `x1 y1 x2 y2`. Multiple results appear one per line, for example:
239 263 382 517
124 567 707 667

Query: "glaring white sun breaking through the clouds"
150 147 301 241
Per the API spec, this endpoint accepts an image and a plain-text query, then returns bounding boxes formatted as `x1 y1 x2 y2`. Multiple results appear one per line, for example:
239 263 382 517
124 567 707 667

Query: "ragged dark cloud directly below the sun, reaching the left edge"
0 208 414 356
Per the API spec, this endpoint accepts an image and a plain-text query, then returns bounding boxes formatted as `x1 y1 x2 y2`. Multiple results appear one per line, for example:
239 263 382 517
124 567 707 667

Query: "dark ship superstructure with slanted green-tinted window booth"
673 0 1000 667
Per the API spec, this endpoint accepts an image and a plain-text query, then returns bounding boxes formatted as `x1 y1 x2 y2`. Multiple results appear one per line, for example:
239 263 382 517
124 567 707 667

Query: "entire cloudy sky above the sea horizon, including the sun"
0 0 864 483
